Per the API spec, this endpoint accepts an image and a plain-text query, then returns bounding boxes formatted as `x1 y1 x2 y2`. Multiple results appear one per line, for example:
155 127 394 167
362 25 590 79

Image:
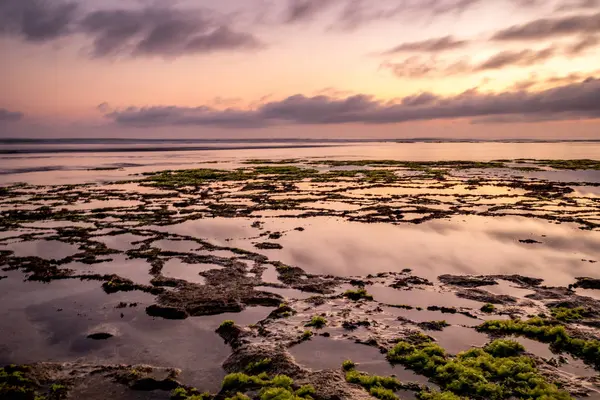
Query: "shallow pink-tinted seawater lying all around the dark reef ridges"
0 143 600 398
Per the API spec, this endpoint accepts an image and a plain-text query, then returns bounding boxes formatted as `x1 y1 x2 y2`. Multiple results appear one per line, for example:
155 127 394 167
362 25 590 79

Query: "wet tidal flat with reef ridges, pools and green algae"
0 157 600 400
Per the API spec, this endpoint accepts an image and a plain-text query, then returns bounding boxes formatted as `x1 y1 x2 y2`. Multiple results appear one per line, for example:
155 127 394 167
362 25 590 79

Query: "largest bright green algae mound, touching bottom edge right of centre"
387 340 571 400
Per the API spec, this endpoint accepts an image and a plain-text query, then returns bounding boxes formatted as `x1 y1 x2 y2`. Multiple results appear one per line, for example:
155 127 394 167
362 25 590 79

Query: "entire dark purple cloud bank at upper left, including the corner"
0 0 264 57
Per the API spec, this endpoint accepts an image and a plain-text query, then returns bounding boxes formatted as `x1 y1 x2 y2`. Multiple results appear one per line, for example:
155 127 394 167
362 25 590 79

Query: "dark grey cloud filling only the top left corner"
0 0 78 42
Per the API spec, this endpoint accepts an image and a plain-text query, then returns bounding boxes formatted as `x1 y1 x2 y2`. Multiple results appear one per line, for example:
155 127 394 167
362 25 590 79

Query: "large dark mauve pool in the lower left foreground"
0 274 272 392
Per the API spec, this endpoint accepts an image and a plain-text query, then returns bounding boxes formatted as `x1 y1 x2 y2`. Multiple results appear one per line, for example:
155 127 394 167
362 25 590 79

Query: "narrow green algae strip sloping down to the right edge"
477 317 600 369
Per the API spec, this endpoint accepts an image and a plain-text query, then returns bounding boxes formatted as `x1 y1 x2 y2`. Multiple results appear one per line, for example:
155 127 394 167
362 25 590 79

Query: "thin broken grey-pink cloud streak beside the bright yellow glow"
381 47 557 79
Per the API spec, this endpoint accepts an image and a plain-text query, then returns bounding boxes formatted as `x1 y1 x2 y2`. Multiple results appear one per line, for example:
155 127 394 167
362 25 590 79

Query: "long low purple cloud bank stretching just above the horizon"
106 78 600 128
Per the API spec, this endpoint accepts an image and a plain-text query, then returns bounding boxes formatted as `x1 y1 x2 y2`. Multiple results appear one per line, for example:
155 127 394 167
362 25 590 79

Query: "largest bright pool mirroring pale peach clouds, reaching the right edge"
254 217 600 284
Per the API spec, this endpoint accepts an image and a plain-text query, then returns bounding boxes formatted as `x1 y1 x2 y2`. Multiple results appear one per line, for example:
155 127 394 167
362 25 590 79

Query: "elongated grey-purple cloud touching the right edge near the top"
492 13 600 41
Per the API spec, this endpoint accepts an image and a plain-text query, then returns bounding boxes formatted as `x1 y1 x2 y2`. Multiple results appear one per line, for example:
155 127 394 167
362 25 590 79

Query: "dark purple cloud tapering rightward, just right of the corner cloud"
81 7 261 57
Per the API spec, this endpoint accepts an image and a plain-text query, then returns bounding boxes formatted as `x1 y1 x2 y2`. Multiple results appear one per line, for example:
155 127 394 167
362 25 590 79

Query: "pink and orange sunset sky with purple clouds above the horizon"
0 0 600 139
